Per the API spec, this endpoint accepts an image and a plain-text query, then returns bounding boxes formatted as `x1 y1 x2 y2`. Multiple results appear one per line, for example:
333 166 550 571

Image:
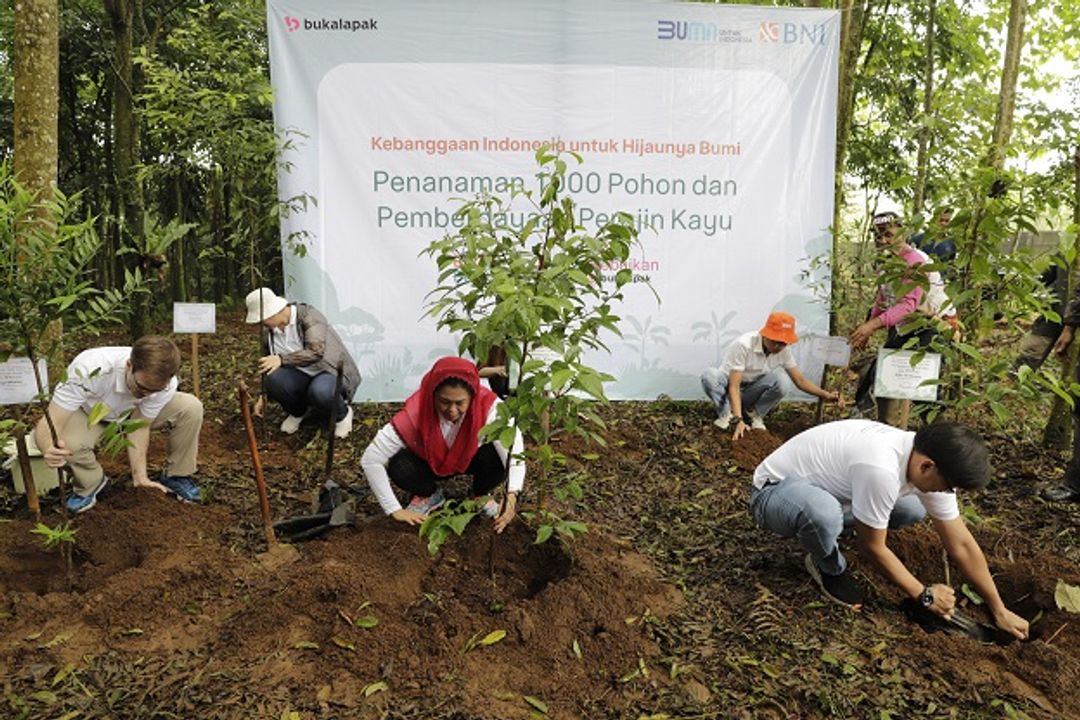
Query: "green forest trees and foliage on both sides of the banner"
6 0 1080 433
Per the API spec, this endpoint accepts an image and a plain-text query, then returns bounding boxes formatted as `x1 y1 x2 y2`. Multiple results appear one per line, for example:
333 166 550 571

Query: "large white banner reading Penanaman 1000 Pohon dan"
268 0 839 400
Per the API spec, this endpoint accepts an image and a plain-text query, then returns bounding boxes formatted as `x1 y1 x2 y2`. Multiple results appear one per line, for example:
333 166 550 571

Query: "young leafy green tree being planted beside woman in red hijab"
427 147 637 541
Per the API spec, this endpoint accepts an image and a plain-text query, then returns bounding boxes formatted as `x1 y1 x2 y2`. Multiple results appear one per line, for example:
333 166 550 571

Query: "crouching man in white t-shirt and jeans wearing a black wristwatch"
751 420 1028 638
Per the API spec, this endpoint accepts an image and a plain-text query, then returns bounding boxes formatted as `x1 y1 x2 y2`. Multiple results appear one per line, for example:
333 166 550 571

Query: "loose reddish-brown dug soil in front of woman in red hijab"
0 483 679 718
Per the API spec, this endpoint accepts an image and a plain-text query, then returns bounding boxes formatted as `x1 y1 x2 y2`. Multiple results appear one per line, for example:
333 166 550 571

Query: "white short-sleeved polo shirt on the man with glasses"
52 348 179 421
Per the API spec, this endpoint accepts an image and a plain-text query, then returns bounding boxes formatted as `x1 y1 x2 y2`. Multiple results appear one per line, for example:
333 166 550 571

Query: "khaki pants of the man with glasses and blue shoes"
60 393 202 494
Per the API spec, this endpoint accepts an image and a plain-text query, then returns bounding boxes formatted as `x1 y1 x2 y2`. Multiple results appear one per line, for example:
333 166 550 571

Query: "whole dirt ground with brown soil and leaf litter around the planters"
0 318 1080 720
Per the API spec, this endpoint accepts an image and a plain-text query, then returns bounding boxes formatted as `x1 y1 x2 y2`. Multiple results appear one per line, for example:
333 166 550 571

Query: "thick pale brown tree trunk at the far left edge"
14 0 59 199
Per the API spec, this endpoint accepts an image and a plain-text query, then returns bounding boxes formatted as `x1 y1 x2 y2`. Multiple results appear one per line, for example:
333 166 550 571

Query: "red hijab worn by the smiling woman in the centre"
390 357 497 477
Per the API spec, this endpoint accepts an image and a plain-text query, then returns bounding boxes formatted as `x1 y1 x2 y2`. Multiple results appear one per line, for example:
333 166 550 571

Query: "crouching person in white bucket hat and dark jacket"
245 287 361 437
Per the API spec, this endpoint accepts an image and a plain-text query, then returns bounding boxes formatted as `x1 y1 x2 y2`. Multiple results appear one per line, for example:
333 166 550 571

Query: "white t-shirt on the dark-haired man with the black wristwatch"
754 420 960 530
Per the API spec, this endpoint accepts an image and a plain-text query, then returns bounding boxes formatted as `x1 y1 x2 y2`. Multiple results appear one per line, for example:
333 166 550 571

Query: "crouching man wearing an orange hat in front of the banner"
701 312 843 440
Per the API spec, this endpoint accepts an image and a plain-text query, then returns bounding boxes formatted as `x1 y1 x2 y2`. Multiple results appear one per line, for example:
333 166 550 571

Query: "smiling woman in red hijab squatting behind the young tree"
360 357 525 532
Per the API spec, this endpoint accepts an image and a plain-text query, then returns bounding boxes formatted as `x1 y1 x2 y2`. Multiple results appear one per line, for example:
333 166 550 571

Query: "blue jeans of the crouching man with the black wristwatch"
750 478 927 575
